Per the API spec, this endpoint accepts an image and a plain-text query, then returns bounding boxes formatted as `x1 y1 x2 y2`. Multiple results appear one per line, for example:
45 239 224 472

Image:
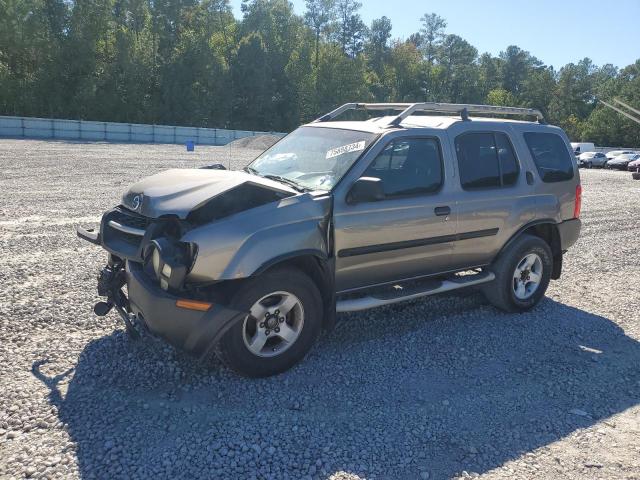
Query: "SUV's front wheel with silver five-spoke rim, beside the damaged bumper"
215 268 323 377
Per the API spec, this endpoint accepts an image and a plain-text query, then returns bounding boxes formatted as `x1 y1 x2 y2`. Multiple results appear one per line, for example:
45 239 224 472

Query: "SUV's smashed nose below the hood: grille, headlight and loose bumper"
78 207 255 357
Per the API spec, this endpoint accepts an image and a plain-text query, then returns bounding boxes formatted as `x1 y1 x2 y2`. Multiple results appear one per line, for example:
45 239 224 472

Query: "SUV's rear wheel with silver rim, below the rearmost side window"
483 234 553 312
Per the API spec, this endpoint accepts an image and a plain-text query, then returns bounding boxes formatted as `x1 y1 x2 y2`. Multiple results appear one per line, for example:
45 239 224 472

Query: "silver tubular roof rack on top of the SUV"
314 102 545 127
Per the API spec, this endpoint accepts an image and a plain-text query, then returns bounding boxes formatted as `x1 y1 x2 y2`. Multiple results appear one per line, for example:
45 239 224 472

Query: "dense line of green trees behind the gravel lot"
0 0 640 145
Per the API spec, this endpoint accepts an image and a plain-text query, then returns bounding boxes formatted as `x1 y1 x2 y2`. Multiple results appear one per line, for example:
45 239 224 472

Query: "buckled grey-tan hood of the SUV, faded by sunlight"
122 169 297 218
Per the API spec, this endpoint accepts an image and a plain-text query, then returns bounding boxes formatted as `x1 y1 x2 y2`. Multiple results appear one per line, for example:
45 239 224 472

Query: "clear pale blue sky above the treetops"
231 0 640 68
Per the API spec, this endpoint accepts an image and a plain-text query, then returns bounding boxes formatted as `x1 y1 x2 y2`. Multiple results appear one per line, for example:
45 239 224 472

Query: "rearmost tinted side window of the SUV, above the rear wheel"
524 132 573 183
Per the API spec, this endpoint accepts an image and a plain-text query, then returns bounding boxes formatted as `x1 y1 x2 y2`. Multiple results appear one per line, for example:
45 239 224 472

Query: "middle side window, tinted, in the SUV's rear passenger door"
456 132 520 190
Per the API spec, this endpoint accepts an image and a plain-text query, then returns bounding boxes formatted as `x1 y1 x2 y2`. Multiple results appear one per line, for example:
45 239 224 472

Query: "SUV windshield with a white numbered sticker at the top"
247 127 376 191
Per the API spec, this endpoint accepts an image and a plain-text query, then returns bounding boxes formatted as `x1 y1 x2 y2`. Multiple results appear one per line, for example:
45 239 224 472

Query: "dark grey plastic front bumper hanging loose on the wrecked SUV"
126 261 247 358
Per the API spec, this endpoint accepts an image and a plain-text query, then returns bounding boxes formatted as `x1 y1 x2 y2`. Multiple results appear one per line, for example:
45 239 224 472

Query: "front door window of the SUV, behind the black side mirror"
363 138 443 197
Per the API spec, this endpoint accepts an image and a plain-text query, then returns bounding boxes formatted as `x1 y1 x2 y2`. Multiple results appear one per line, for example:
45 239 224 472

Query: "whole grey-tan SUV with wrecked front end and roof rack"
78 103 581 376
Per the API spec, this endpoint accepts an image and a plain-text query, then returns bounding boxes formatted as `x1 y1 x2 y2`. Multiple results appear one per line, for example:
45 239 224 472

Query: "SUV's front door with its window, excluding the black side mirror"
334 136 456 292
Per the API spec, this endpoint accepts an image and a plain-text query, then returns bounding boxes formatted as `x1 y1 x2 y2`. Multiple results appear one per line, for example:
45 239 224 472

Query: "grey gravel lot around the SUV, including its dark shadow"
0 140 640 480
